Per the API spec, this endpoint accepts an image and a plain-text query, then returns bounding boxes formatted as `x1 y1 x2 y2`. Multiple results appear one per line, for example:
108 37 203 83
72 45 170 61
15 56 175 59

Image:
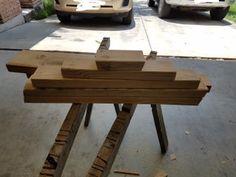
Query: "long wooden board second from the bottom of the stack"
24 79 208 98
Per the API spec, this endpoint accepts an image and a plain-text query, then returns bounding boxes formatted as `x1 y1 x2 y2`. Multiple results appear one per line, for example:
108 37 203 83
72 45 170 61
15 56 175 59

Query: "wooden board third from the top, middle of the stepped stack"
31 66 201 89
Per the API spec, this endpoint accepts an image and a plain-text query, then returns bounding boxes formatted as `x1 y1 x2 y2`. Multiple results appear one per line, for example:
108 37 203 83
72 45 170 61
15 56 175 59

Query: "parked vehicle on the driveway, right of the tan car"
148 0 233 20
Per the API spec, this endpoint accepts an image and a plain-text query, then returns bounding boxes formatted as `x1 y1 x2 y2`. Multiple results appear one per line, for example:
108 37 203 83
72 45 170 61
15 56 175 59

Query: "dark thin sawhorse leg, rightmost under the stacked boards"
151 104 168 154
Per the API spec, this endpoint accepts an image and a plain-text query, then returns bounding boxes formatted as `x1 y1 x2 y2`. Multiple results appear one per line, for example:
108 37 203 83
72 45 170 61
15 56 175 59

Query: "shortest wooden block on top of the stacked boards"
96 50 145 71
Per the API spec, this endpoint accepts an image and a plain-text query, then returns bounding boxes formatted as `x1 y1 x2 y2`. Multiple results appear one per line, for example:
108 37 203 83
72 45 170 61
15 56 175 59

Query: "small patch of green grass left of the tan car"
34 0 55 20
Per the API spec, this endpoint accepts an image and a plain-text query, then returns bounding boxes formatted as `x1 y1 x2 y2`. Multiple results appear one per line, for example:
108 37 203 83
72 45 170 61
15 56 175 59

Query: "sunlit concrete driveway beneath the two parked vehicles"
0 0 236 58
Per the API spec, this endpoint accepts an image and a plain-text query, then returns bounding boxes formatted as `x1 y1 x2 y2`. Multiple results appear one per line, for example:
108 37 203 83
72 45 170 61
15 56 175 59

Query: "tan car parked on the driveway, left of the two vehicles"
54 0 133 25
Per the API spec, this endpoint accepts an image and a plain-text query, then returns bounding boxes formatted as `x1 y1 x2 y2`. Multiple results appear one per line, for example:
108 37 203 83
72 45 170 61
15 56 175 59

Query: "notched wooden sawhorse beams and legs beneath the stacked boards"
39 103 168 177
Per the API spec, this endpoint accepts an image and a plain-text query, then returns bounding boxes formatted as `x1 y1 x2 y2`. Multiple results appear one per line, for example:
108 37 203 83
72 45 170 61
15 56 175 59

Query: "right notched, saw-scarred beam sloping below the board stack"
86 104 136 177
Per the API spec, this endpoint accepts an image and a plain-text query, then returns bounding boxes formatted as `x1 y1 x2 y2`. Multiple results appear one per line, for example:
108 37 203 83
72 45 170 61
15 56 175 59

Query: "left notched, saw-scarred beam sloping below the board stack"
40 104 86 177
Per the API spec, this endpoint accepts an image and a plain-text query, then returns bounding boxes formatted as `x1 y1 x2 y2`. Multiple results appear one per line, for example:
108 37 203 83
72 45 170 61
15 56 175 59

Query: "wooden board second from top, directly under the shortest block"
61 58 176 80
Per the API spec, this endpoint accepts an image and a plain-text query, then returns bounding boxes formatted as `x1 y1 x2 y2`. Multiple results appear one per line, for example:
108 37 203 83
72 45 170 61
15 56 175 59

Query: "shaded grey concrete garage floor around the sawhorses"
0 51 236 177
